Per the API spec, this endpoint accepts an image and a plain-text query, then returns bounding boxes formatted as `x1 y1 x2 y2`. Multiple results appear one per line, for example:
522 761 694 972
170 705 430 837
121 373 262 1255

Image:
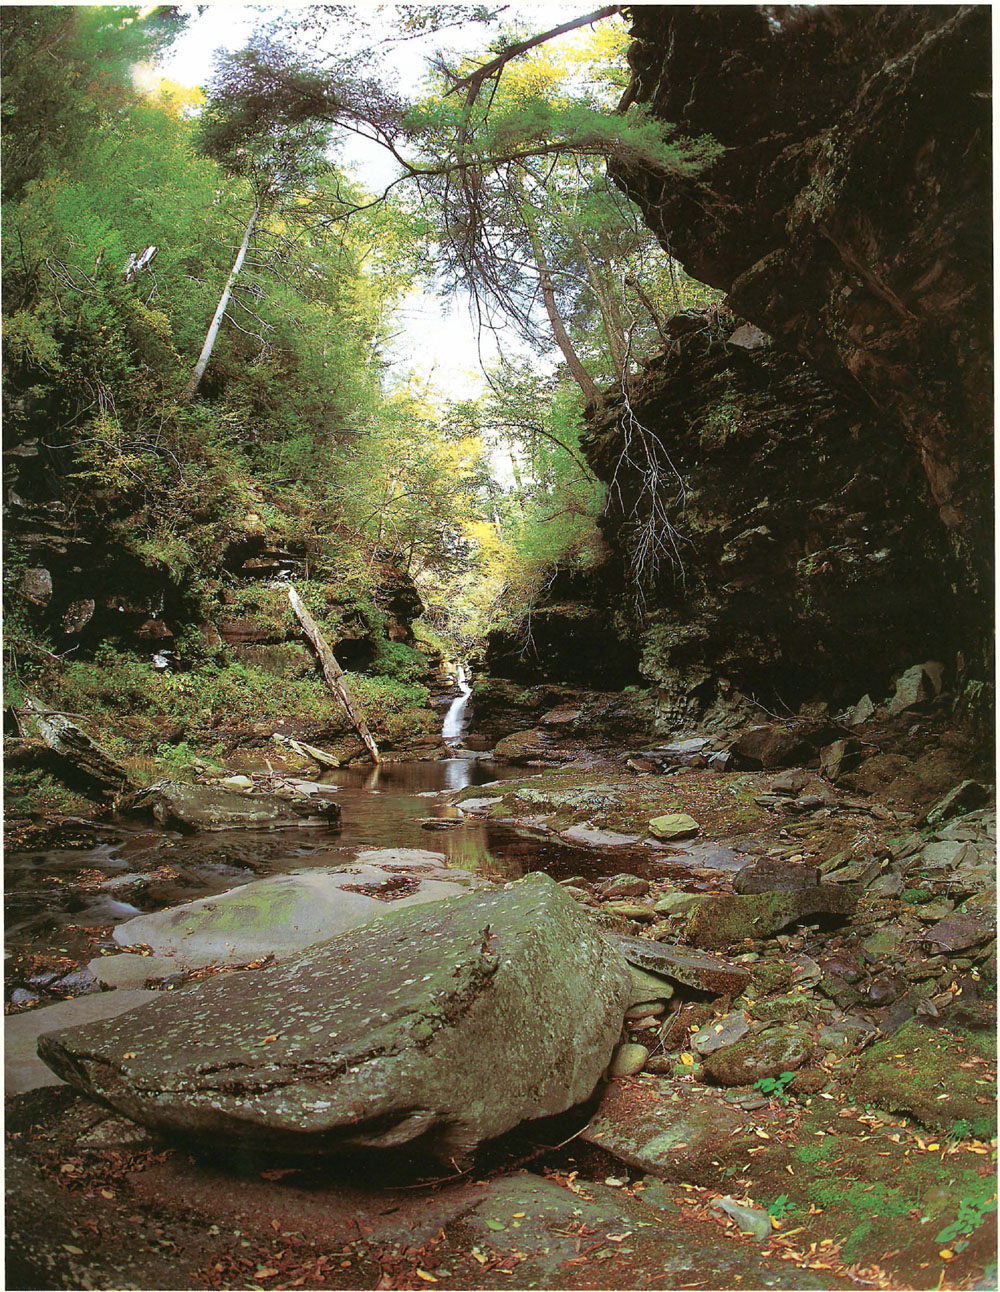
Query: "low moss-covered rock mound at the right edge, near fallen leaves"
853 1019 996 1138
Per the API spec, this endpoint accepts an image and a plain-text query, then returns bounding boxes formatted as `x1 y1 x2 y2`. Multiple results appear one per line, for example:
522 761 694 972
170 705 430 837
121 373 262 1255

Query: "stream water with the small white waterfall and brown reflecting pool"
5 673 630 976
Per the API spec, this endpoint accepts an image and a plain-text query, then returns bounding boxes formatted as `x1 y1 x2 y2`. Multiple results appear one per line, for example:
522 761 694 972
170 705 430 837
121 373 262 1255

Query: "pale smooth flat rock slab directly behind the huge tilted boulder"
112 849 475 970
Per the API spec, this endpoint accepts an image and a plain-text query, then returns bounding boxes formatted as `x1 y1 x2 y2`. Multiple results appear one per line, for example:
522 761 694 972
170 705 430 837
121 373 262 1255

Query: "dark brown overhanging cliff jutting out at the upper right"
615 5 992 678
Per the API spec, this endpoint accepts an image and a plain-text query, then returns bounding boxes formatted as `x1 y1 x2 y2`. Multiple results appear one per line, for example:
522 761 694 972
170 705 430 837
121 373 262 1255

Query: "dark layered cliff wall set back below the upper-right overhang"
584 323 963 729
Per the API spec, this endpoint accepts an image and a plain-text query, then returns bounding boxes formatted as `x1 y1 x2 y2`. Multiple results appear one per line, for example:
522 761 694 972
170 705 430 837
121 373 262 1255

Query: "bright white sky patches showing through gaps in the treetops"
158 3 587 399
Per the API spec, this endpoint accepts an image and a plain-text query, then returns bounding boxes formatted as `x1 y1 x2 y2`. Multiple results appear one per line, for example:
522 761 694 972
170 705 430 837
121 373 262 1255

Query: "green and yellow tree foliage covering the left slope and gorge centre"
0 6 717 771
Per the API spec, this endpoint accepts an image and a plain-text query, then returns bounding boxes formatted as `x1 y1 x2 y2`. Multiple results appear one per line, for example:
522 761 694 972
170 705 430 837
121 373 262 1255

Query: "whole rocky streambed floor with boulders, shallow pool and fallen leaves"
8 708 996 1288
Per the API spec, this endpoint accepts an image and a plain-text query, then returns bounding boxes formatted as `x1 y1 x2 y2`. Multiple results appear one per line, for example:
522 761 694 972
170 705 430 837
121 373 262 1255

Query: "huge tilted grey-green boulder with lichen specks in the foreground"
39 873 630 1160
